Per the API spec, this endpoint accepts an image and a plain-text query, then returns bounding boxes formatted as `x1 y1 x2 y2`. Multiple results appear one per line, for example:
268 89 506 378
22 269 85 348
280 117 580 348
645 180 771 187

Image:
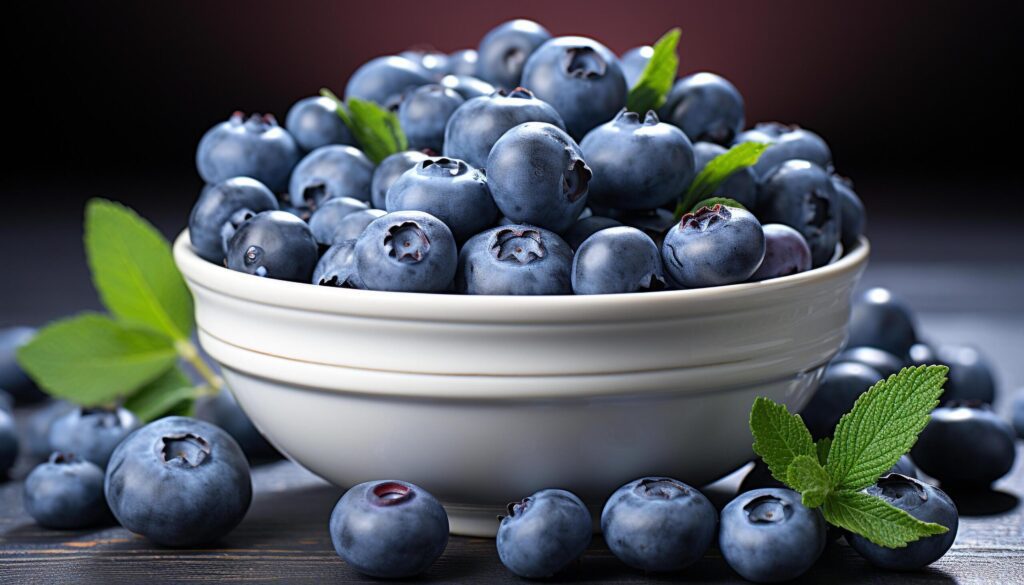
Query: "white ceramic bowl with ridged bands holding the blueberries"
174 233 868 536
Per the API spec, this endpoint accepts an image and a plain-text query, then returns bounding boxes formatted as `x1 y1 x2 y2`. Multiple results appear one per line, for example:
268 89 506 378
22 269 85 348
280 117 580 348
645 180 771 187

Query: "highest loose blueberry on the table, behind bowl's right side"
850 288 918 356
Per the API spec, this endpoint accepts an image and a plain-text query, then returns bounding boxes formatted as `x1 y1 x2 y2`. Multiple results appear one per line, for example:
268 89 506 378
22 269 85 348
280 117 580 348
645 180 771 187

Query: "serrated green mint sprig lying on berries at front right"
751 366 949 548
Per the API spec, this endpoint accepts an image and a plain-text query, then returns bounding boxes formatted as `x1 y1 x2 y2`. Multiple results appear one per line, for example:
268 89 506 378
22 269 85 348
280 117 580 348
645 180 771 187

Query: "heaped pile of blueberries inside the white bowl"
188 20 864 295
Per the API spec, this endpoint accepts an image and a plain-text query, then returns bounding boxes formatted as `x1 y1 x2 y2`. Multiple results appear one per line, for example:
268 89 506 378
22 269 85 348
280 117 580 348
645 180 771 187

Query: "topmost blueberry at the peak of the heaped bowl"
476 19 551 89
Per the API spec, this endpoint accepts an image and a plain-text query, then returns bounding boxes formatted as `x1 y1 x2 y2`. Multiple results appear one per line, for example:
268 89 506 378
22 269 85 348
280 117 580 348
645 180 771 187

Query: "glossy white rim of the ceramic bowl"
173 229 870 324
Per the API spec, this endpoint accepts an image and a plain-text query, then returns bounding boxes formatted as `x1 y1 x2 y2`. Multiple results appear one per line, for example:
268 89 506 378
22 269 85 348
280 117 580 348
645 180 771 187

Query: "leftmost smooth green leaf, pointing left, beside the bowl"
17 314 177 406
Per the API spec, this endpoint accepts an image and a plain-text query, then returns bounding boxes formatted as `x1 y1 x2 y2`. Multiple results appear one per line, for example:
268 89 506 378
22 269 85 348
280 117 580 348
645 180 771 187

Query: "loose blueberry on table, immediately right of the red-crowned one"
497 490 593 579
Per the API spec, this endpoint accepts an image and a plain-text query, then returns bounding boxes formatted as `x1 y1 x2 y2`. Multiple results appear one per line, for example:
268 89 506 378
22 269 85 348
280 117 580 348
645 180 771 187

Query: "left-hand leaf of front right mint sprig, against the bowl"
751 396 815 484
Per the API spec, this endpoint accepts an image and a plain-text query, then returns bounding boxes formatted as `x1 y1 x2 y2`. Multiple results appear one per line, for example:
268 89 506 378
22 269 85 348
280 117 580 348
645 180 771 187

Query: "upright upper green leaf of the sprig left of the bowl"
85 199 196 339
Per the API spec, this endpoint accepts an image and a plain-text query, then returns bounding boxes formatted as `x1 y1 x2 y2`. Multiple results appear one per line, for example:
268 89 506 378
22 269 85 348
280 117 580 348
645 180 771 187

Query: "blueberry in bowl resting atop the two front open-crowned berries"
386 157 498 242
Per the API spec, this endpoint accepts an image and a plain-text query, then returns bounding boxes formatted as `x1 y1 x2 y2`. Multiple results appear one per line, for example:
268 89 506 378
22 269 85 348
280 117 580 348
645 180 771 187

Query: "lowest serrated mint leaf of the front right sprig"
821 491 949 548
